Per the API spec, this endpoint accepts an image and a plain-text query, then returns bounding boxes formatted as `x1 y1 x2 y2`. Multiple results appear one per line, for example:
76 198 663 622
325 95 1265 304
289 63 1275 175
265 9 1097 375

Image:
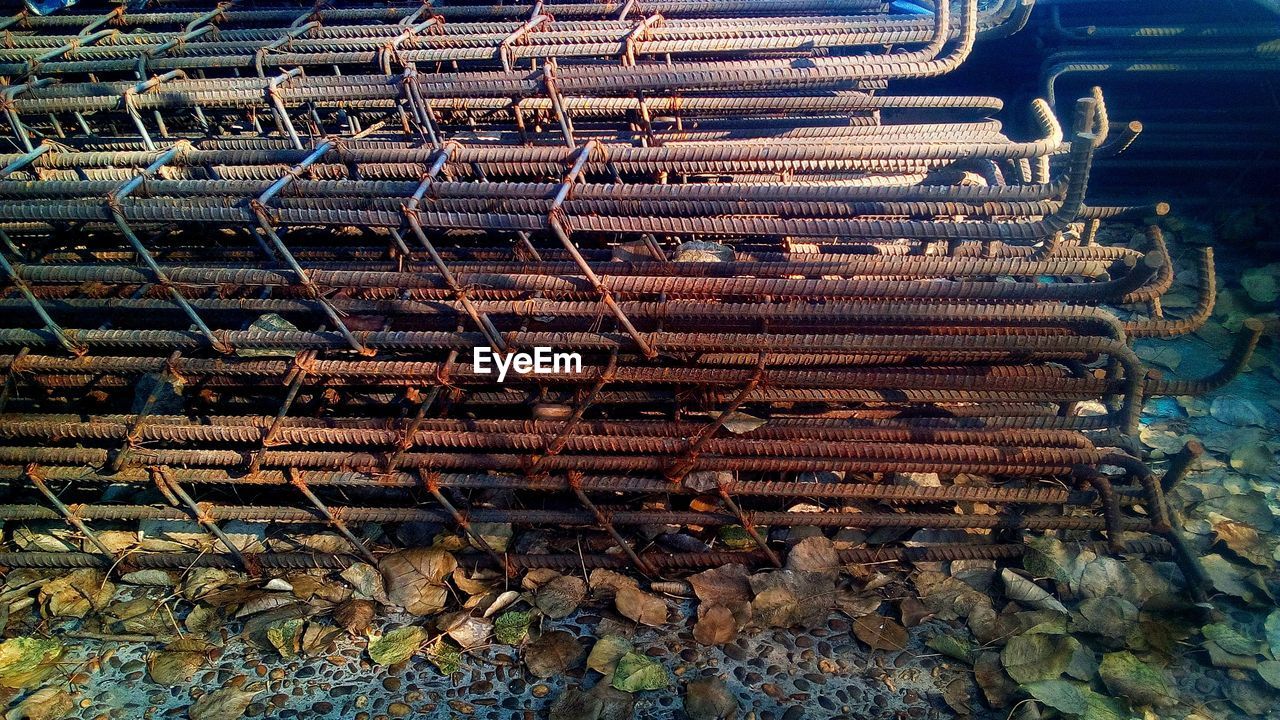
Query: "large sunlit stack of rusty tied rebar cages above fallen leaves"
0 0 1257 584
